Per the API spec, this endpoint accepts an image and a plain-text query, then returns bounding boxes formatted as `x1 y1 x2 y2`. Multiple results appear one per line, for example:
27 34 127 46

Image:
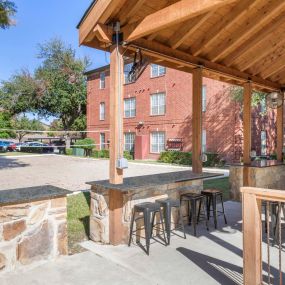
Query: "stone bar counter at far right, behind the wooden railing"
230 160 285 201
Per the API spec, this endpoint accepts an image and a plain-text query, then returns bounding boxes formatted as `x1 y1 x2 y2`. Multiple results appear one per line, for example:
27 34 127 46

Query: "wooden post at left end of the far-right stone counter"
243 82 252 164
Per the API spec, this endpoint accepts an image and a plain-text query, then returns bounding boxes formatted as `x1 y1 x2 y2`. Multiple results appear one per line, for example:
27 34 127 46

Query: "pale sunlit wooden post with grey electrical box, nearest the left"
109 43 124 184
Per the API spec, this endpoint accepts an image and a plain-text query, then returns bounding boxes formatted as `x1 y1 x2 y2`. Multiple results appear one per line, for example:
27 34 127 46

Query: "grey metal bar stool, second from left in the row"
155 198 186 244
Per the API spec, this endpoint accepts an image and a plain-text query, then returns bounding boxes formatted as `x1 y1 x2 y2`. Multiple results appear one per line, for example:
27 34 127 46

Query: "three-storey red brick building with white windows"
86 65 276 161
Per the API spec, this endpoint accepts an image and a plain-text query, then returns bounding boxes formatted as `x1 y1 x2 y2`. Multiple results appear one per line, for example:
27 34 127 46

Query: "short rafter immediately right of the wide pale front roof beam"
168 10 213 49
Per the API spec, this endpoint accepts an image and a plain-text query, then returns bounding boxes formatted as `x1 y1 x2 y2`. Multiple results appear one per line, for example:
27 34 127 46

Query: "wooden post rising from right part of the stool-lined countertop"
192 68 202 173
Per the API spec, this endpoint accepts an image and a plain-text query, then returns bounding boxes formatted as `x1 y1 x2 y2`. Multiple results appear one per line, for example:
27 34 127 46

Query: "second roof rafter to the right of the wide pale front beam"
191 0 255 56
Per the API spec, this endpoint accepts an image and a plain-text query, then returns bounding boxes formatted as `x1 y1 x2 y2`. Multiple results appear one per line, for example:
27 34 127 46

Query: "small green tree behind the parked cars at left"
12 116 44 142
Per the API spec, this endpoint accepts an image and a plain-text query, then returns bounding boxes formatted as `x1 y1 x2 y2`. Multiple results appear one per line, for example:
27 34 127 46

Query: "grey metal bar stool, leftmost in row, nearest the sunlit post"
128 202 167 255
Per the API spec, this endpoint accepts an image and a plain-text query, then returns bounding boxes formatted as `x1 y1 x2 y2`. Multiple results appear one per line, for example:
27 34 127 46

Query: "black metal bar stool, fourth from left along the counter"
201 189 227 229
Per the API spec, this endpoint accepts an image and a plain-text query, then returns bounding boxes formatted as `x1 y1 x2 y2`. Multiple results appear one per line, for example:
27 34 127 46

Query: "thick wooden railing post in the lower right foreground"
242 189 262 285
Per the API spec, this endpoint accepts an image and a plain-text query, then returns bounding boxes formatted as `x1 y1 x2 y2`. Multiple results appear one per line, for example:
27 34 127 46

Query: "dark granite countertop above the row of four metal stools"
86 170 223 192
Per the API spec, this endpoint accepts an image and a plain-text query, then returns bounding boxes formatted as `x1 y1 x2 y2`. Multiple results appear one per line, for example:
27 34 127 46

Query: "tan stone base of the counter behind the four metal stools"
90 180 203 244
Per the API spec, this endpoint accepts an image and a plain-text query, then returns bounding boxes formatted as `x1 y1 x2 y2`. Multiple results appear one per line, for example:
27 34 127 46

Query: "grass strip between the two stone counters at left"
67 192 90 254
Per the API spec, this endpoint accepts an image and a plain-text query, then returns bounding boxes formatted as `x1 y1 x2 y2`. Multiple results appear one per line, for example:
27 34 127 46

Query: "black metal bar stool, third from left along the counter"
180 193 209 236
